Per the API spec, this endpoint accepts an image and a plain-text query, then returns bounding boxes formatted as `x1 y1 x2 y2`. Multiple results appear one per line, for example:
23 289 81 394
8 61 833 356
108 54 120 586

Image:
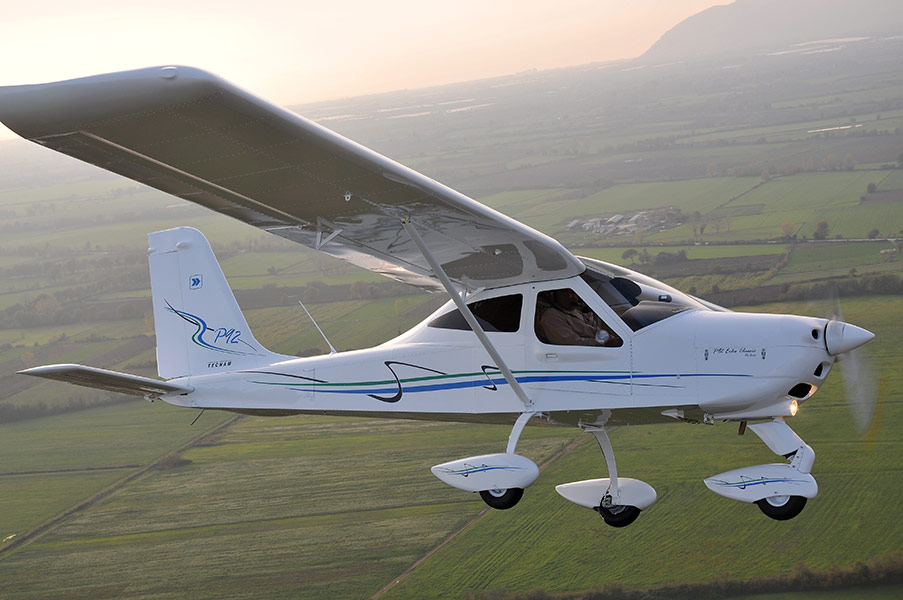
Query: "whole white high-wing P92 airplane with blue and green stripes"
0 67 874 527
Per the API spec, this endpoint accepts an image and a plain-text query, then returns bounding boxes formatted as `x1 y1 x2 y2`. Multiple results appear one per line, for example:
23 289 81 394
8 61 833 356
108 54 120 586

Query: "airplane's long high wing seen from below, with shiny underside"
0 67 584 289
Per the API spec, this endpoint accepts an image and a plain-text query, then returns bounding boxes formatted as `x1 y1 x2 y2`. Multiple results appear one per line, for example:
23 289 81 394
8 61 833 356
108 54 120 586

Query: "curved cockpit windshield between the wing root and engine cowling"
580 257 711 331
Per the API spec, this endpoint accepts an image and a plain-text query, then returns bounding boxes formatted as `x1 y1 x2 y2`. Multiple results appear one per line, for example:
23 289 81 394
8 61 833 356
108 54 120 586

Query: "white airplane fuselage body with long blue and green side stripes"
164 278 834 432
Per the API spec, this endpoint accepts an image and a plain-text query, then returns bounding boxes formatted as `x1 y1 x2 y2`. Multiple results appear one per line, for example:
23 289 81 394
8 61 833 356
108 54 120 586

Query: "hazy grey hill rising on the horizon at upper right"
641 0 903 61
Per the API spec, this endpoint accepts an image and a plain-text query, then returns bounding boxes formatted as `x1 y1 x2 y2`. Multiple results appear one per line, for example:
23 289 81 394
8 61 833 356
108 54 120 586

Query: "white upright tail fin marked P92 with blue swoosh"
147 227 291 379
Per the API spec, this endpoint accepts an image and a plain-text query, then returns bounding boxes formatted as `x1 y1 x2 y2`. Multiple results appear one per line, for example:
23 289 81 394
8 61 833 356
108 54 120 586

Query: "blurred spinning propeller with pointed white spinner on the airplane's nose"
825 285 878 435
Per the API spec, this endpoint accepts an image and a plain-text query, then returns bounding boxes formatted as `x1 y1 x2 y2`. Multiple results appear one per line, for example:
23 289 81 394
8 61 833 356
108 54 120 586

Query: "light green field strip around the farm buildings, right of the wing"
481 170 903 247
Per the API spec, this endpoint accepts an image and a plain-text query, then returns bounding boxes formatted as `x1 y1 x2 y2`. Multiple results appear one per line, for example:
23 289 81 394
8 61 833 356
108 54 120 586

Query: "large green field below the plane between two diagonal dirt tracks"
0 409 573 599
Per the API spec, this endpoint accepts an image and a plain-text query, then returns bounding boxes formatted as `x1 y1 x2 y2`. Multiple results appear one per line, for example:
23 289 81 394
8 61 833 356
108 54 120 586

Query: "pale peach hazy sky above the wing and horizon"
0 0 729 110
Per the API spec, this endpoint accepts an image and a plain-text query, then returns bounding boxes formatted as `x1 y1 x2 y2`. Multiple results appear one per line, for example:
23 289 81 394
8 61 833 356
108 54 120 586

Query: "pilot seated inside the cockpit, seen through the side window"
539 288 619 346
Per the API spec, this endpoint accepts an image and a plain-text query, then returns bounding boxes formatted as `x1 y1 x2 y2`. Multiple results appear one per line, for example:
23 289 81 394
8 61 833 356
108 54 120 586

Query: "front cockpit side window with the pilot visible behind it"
534 288 624 348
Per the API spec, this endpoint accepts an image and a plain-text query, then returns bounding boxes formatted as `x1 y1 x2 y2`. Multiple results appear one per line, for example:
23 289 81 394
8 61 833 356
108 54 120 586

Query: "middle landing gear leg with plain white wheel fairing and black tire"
555 427 656 527
